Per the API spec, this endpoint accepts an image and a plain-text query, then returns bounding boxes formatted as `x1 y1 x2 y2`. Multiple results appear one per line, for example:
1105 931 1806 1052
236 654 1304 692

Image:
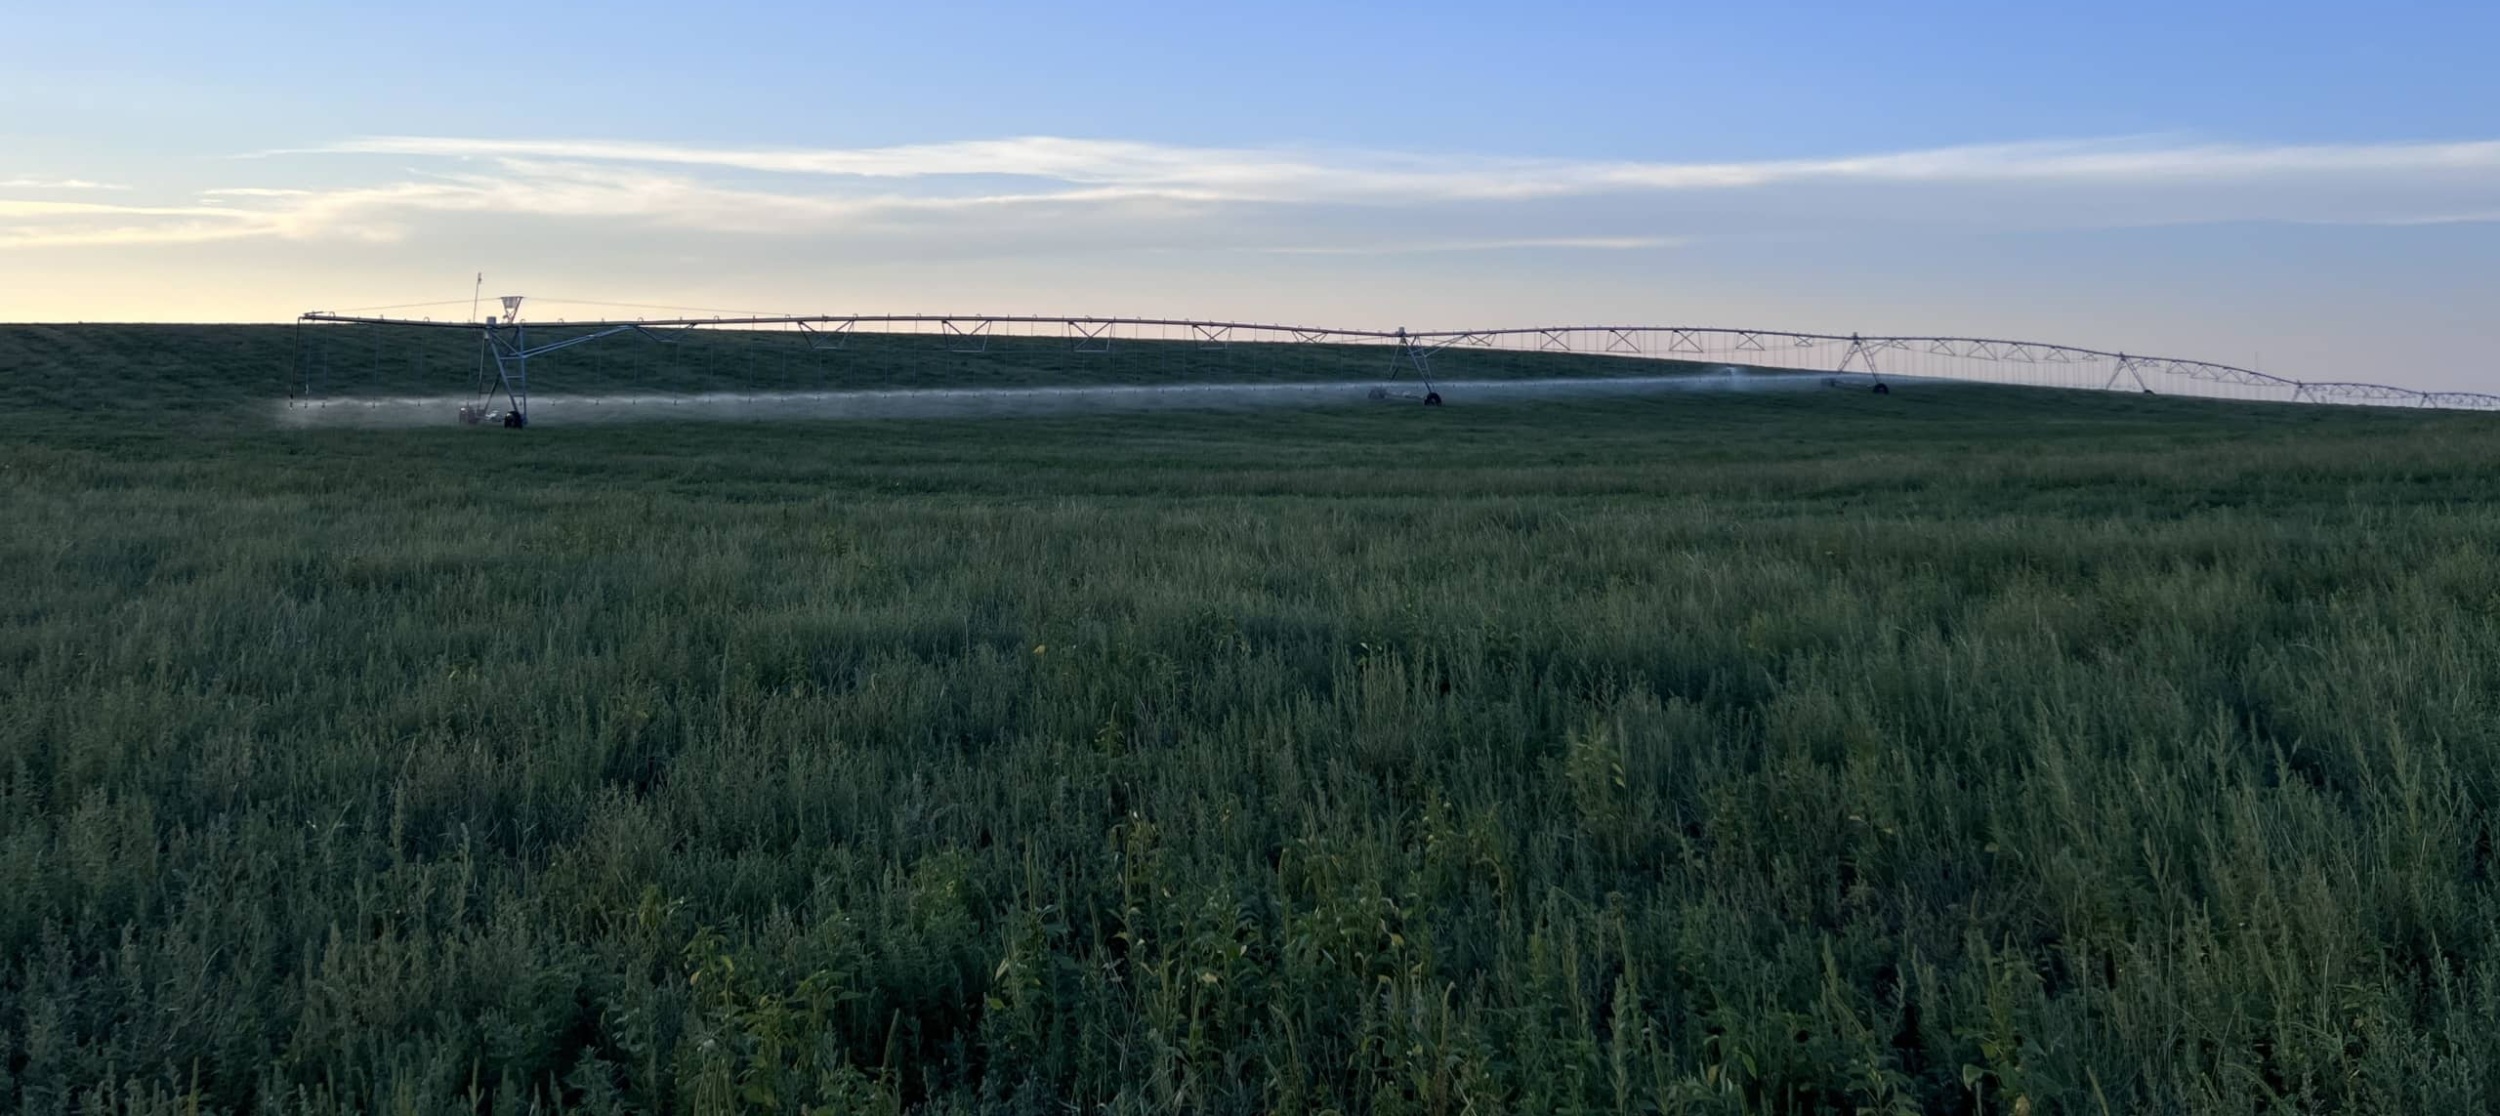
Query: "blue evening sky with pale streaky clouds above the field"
0 0 2500 390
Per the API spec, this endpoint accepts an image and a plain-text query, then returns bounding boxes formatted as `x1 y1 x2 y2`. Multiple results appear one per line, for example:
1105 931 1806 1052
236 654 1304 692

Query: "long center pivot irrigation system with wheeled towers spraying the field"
295 295 2500 428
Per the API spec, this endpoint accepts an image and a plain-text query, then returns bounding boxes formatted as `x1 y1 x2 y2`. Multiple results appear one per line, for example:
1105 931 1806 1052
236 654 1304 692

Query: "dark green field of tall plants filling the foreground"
0 328 2500 1113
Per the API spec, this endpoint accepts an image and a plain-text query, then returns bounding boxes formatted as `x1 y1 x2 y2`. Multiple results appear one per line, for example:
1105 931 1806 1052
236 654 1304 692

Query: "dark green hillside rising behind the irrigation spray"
0 325 1723 425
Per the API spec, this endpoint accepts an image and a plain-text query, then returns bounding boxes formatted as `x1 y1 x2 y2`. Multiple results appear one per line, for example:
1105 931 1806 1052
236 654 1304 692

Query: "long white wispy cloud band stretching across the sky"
14 135 2500 255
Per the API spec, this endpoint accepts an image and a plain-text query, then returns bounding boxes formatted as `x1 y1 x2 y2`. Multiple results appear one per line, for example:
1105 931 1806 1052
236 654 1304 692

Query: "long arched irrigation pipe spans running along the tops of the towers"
298 310 2500 410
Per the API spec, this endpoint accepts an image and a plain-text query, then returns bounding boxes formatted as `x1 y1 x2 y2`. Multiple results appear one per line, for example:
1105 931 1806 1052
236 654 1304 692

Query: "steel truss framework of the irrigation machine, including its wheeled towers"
298 309 2500 425
